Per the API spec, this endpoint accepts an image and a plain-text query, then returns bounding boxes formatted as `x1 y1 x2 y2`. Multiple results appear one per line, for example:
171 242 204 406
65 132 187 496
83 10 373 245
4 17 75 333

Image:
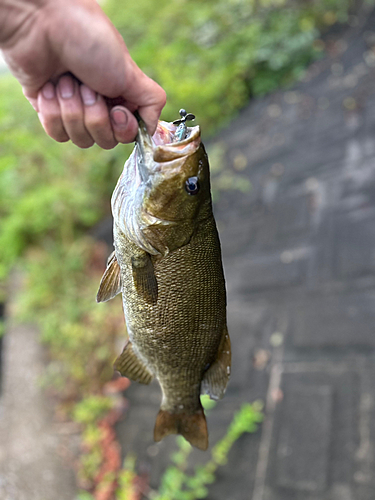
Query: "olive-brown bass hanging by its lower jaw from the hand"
97 113 231 450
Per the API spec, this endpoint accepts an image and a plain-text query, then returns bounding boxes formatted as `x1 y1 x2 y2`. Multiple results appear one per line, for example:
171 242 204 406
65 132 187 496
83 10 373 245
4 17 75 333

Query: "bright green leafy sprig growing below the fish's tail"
151 402 263 500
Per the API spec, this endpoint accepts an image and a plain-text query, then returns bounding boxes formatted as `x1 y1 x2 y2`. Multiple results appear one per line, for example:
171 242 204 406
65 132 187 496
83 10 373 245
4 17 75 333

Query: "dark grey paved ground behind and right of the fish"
118 4 375 500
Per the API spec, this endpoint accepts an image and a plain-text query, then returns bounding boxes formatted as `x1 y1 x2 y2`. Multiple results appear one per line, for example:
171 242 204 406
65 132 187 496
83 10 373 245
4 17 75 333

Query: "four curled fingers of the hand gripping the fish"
37 75 138 149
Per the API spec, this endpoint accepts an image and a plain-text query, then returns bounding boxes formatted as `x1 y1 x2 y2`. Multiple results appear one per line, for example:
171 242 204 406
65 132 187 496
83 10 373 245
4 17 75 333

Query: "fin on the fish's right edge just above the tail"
201 327 231 399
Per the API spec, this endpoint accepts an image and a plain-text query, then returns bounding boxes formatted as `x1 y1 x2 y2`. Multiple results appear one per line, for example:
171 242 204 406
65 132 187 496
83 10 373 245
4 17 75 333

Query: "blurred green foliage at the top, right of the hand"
103 0 351 133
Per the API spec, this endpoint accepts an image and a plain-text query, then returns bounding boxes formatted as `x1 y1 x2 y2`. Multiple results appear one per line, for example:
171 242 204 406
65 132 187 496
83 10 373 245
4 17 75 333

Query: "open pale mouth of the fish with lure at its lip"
136 114 201 177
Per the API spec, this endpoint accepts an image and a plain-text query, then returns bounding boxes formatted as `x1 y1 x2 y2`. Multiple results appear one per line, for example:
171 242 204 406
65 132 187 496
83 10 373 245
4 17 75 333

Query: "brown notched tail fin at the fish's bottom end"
154 408 208 451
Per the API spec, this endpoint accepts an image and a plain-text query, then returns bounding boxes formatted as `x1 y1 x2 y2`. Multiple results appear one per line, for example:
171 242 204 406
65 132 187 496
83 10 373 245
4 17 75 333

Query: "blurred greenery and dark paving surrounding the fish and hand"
0 0 375 500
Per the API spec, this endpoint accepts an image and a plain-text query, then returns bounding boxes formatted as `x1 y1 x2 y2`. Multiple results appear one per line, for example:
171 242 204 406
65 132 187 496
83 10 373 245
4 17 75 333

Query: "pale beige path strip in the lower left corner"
0 280 77 500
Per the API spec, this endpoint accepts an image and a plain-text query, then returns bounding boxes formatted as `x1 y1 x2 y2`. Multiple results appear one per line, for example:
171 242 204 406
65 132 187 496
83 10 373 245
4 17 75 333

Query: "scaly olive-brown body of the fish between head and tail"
116 220 226 383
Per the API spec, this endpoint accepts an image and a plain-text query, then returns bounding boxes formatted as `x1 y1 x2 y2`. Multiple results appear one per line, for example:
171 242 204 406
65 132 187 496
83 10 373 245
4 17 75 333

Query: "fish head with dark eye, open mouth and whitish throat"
112 116 212 255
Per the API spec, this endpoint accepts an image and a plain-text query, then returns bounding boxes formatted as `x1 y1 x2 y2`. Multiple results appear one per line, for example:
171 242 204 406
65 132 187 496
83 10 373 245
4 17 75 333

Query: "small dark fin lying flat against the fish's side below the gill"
131 252 158 304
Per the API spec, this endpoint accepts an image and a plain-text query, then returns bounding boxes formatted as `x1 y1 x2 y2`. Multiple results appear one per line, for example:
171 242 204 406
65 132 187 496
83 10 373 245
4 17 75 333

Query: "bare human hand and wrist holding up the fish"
0 0 165 149
